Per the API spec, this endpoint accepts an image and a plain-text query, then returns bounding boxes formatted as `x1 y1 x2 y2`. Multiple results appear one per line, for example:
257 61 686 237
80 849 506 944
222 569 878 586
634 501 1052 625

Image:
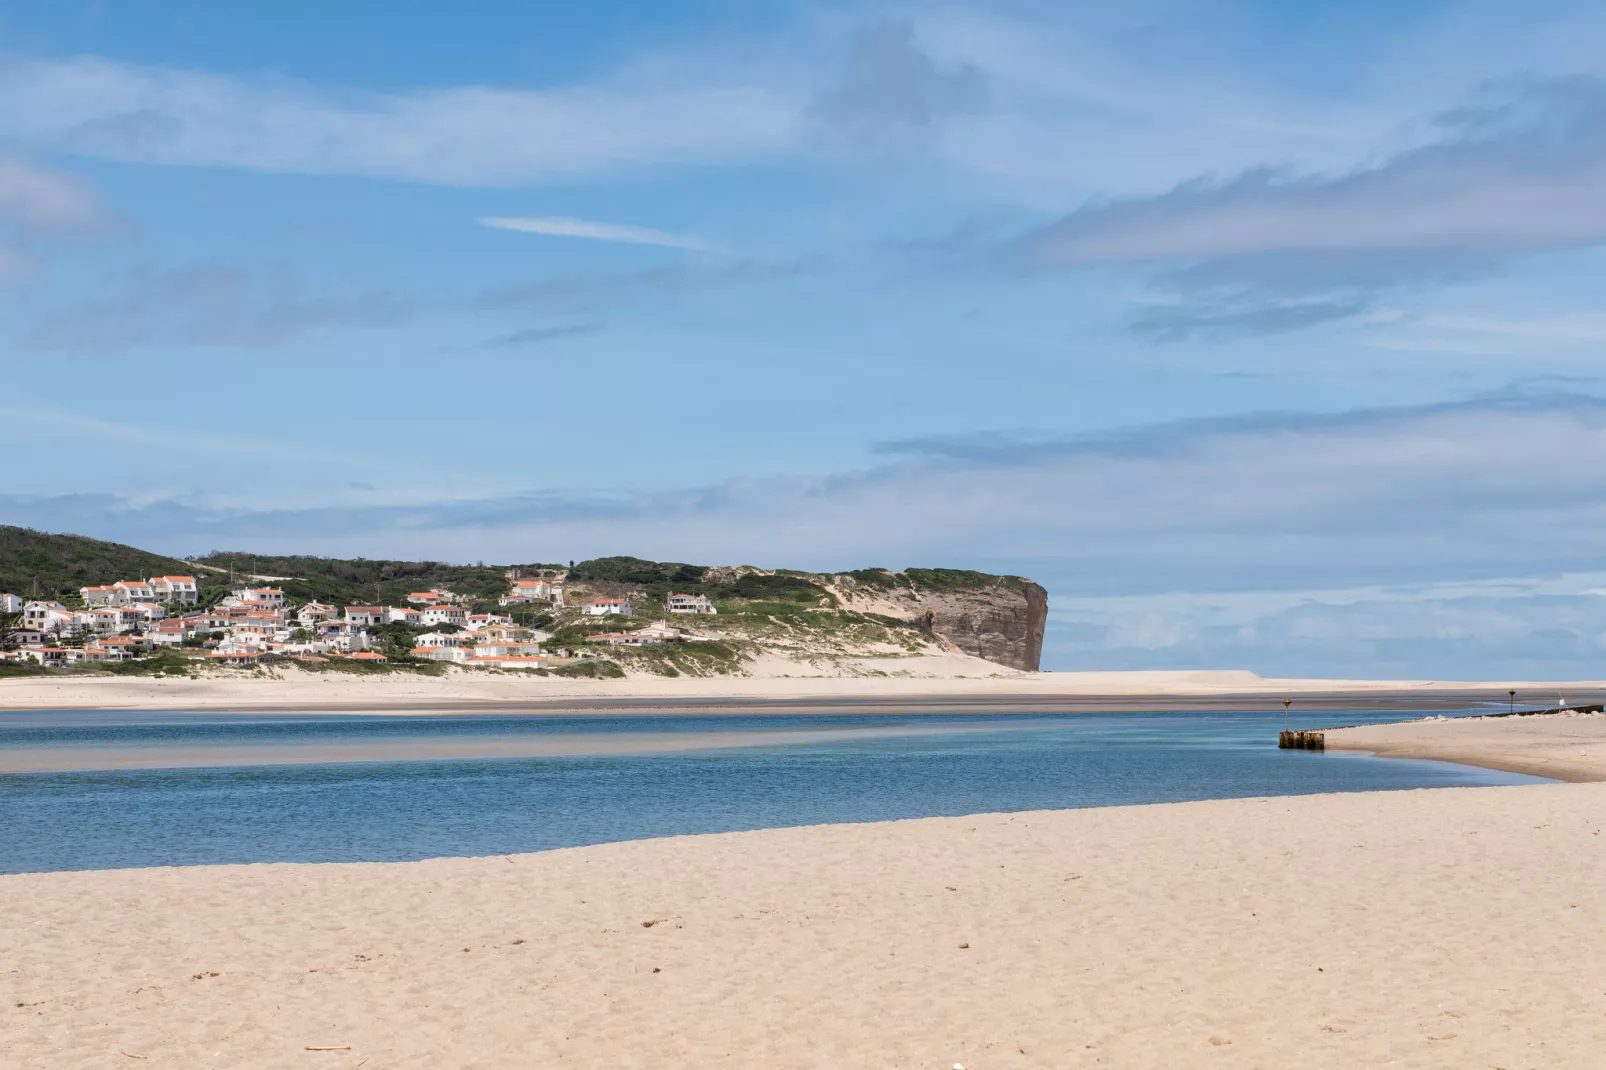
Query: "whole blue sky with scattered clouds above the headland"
0 0 1606 680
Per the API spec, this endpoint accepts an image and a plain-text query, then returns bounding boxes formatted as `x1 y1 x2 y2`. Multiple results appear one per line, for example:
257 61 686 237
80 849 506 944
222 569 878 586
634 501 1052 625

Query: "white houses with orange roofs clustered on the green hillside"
0 574 716 668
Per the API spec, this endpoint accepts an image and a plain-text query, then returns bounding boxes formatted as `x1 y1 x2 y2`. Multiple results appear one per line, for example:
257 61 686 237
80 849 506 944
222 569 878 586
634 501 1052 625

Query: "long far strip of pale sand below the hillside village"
0 659 1606 713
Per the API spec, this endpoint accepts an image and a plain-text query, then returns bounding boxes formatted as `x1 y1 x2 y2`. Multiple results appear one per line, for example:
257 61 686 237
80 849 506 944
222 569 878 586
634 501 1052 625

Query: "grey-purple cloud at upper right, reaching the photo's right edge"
1018 77 1606 339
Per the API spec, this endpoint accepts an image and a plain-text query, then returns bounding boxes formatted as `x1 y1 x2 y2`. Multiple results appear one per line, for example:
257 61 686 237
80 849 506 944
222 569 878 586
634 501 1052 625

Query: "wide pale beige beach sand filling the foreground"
0 784 1606 1070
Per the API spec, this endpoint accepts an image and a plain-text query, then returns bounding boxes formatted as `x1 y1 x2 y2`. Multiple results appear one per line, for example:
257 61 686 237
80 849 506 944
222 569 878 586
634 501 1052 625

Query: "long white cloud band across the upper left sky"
0 58 798 185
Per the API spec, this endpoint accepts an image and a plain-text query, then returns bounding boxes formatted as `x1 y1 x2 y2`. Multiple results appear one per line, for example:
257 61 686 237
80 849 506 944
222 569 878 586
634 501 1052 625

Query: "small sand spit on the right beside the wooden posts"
1327 713 1606 781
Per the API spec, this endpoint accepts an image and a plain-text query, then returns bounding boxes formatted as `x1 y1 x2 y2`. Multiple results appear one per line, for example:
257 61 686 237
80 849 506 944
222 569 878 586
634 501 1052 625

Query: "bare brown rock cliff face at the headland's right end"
832 569 1049 672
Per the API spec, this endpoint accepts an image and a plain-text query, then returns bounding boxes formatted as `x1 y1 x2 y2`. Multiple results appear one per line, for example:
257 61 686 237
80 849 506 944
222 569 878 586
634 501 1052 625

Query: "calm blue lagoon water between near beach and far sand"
0 712 1539 872
